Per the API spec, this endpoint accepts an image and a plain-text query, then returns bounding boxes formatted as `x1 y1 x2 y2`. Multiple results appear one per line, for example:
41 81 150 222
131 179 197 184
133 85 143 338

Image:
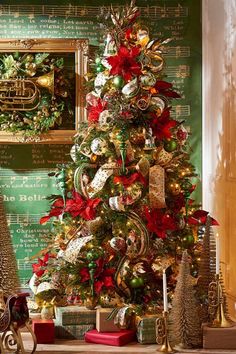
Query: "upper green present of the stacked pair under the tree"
55 306 96 326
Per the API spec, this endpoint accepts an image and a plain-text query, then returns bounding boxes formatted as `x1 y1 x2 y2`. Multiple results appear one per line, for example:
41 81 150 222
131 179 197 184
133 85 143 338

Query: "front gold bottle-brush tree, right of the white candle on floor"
170 251 202 348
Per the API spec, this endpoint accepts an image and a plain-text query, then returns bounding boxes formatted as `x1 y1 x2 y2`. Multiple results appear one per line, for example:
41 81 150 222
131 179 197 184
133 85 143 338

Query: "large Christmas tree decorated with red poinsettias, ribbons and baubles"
30 2 210 316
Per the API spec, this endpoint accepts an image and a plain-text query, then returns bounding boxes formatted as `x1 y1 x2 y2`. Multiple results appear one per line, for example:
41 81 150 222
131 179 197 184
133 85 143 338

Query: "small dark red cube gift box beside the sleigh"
32 319 55 344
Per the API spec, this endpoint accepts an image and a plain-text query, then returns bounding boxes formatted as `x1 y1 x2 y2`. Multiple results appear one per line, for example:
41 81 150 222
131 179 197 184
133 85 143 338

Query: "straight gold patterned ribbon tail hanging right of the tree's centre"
149 165 166 209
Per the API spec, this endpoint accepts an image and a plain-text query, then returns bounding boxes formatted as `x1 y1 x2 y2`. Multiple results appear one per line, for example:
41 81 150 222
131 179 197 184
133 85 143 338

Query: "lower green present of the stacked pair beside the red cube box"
54 320 94 339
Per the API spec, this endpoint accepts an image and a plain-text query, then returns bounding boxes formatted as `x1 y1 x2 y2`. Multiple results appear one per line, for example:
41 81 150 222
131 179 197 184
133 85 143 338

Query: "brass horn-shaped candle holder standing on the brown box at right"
208 274 233 328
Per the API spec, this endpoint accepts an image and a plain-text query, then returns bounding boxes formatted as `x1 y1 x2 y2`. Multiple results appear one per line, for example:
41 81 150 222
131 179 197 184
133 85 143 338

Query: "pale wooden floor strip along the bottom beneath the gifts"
20 333 236 354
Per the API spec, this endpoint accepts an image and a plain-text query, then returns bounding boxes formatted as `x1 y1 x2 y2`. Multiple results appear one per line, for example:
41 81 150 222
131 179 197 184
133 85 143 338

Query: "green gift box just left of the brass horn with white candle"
136 315 158 344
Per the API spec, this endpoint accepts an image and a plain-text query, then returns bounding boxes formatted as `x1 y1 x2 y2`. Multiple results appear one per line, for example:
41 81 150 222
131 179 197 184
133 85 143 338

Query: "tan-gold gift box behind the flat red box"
96 308 120 332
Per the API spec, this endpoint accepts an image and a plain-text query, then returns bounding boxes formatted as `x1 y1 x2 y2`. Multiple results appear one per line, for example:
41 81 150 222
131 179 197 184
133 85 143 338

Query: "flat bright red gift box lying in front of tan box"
84 329 136 346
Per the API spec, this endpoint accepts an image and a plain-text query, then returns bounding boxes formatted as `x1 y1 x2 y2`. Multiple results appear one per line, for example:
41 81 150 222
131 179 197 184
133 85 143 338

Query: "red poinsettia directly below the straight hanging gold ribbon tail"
144 207 178 239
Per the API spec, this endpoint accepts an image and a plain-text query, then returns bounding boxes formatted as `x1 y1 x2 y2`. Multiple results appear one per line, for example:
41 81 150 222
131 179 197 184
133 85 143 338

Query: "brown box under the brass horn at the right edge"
203 323 236 349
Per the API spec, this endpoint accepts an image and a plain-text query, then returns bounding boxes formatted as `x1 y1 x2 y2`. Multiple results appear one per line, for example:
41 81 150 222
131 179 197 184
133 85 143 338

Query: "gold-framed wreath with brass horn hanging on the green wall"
0 39 88 142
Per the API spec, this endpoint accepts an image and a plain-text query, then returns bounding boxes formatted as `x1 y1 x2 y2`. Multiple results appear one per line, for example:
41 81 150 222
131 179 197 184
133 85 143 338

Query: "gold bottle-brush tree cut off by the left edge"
0 196 20 296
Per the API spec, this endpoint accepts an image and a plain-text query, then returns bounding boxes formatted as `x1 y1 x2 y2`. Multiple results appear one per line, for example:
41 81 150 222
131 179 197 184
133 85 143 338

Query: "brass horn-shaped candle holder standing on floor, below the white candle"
156 311 175 353
